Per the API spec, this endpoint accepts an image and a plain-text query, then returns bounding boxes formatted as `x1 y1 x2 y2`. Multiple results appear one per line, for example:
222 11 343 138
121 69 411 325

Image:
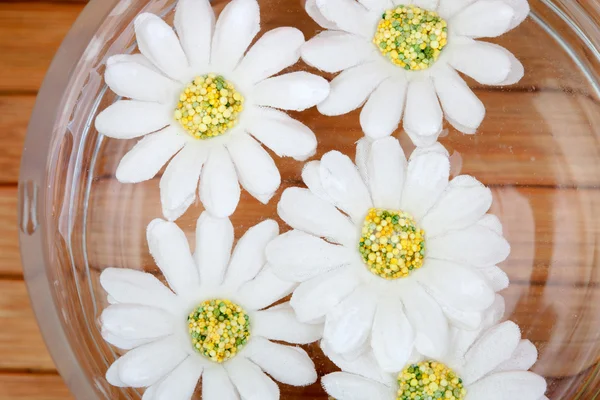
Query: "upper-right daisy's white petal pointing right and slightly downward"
449 41 514 85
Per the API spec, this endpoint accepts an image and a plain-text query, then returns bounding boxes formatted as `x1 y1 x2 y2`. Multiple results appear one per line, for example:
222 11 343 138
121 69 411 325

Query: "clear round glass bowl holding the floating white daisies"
19 0 600 400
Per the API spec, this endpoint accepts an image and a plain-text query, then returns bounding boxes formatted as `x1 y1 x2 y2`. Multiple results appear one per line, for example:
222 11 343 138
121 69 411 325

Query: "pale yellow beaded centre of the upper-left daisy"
175 74 244 139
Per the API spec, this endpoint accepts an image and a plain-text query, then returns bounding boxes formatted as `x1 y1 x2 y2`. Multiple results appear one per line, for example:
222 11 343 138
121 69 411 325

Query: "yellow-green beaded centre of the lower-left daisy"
188 299 250 363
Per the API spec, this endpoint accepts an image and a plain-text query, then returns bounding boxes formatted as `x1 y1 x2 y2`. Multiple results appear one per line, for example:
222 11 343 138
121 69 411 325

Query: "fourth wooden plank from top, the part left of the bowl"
0 280 55 371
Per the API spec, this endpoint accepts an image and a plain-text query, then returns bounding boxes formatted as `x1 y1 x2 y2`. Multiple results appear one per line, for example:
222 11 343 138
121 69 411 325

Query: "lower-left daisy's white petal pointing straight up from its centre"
194 212 233 287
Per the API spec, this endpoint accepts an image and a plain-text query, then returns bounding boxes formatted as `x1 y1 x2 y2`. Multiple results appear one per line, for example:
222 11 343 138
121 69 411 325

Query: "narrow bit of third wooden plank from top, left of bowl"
0 187 22 277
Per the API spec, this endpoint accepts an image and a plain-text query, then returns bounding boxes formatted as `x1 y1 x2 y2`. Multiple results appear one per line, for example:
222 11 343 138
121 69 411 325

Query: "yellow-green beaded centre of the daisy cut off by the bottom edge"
396 361 467 400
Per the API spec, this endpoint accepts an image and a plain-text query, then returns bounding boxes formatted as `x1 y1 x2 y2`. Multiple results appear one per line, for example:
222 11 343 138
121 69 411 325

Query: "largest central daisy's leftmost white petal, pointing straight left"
267 230 354 282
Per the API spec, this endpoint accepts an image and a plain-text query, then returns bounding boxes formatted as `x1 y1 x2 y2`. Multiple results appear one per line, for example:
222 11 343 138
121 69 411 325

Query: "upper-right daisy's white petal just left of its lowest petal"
360 77 408 139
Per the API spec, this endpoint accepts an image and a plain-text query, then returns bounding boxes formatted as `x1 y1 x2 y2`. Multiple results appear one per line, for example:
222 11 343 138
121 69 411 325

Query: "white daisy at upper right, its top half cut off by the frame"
302 0 529 146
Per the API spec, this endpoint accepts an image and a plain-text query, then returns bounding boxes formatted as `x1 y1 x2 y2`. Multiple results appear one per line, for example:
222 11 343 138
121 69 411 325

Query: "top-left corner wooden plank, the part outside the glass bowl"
0 2 84 92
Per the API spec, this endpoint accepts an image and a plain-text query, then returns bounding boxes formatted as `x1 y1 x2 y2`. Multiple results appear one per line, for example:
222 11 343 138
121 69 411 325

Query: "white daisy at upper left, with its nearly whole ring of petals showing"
96 0 329 220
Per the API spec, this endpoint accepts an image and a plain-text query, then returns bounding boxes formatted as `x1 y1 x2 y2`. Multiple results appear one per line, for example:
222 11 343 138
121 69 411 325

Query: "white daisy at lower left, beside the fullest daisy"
100 212 322 400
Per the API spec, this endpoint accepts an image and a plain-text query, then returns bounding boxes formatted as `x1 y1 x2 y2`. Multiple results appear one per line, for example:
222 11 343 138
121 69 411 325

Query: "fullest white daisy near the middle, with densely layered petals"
267 137 510 372
